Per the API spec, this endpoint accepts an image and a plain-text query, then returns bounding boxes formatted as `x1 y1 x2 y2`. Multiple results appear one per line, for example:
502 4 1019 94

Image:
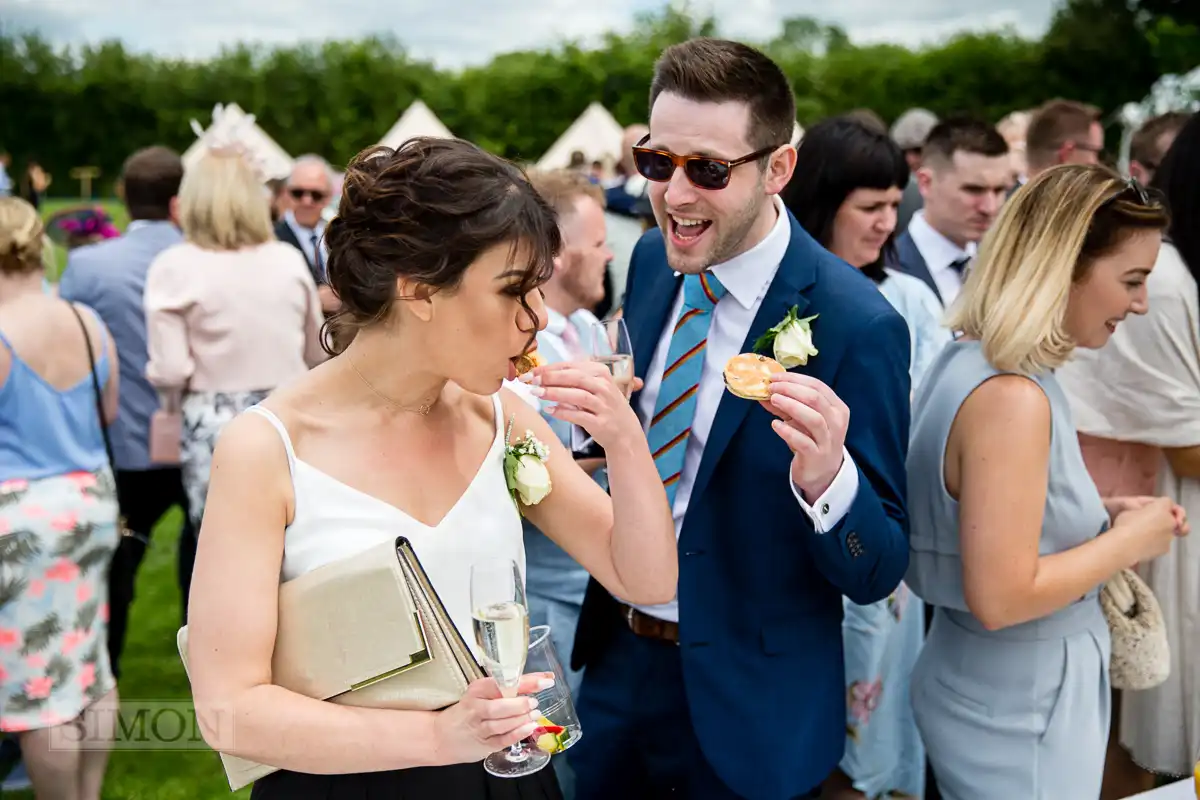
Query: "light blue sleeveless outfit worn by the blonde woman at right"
905 341 1111 800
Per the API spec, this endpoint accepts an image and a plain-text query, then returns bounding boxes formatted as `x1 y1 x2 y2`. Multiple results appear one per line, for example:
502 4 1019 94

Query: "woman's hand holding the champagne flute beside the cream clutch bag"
433 673 553 764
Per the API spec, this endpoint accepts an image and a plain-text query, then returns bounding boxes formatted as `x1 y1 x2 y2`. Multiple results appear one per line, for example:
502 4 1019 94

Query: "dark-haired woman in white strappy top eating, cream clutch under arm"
188 139 678 800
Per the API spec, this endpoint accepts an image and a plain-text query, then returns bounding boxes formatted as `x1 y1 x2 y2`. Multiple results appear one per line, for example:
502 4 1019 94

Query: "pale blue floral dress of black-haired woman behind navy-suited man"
840 270 953 798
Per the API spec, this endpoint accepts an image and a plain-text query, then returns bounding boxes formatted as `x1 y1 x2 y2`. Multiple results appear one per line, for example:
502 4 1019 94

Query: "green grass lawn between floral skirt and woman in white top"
5 509 250 800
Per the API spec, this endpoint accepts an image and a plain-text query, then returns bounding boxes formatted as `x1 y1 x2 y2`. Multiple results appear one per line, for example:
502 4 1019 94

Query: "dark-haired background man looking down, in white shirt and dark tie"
888 118 1013 306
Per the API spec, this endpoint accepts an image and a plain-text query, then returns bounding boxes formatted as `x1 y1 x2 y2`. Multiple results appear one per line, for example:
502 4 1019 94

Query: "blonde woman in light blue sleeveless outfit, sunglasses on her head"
905 166 1188 800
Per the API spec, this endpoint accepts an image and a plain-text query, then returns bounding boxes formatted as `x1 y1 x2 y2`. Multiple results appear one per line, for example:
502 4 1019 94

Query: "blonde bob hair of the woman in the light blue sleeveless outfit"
946 164 1168 374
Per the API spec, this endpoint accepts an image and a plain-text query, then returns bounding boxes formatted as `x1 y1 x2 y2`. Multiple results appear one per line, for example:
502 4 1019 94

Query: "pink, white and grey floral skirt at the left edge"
0 467 120 733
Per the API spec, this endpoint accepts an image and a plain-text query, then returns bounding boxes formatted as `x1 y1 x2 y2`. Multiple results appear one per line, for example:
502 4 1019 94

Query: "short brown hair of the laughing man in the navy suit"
650 37 796 156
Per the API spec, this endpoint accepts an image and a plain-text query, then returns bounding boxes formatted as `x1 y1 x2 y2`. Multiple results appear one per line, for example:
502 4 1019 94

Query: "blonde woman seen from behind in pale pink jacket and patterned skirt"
145 146 325 537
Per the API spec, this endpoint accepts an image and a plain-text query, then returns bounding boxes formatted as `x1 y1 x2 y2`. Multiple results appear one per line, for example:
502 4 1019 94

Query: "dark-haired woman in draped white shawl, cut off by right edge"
1061 115 1200 783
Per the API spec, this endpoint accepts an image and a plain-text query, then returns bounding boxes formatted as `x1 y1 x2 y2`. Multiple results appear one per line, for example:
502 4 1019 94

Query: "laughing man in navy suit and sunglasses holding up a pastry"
569 40 910 800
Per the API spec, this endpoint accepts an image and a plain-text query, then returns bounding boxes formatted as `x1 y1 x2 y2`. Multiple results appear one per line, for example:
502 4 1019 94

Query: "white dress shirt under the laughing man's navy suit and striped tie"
637 198 858 622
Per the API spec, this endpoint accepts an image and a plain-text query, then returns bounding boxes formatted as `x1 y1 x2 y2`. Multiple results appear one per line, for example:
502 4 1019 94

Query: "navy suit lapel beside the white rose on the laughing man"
691 213 818 506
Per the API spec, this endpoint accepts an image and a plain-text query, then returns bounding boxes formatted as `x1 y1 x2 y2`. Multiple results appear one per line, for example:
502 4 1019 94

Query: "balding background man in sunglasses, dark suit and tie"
275 156 340 314
